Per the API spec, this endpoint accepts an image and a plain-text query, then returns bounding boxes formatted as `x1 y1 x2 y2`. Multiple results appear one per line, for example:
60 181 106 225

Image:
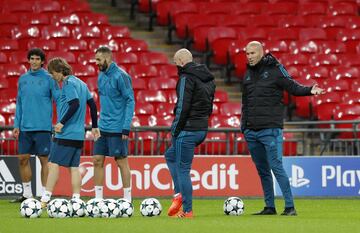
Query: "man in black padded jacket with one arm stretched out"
241 41 325 216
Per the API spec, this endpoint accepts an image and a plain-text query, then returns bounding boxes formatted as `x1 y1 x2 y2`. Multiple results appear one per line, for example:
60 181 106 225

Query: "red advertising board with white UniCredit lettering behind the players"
54 156 262 197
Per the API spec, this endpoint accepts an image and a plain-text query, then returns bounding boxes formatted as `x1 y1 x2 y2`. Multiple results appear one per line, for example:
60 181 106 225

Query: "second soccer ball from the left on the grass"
47 198 73 218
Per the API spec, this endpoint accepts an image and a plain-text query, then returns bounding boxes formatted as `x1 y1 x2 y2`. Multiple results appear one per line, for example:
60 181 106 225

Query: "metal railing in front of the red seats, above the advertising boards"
0 121 360 156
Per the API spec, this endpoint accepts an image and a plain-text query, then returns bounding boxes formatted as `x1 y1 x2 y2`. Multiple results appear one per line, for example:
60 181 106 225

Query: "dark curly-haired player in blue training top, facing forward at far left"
11 48 56 202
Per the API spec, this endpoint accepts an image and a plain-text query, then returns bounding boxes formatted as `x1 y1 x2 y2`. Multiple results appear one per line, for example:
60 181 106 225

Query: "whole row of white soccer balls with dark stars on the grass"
20 197 244 218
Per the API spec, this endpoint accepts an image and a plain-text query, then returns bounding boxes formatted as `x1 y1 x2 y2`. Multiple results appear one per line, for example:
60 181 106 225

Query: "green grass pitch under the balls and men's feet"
0 199 360 233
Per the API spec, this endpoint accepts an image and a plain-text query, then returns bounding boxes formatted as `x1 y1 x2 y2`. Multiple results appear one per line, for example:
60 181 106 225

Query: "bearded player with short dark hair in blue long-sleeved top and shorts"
93 47 135 202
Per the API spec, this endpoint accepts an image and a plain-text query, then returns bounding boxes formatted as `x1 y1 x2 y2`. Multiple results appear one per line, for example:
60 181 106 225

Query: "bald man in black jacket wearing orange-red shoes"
165 49 216 218
